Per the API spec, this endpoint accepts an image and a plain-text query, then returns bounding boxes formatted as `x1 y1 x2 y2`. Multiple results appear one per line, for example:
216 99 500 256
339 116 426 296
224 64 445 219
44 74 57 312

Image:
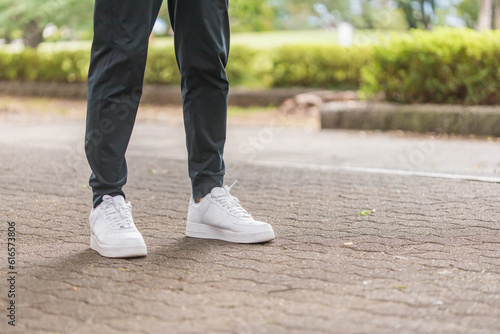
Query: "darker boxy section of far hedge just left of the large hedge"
269 45 372 88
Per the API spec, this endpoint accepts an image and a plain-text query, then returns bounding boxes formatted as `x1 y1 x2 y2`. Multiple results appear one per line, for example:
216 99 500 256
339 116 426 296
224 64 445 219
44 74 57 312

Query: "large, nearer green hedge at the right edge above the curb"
362 29 500 104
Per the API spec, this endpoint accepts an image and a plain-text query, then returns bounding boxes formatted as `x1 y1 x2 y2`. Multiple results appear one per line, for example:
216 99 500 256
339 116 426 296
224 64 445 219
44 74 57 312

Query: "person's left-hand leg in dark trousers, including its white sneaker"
85 0 161 258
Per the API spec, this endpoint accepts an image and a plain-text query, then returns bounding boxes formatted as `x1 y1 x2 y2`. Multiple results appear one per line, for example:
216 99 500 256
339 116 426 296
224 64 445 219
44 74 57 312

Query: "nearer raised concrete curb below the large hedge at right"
321 101 500 137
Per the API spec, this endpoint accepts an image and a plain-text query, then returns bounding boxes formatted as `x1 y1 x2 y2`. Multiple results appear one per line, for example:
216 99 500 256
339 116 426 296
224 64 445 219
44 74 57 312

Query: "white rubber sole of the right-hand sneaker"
186 221 275 244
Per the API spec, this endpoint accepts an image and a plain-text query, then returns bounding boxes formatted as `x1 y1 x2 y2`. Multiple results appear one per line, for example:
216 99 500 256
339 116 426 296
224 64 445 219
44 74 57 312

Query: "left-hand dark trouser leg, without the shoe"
85 0 161 207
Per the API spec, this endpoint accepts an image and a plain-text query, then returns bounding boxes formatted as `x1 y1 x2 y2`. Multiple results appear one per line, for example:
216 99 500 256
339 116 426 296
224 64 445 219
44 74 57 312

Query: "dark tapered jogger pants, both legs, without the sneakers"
85 0 229 206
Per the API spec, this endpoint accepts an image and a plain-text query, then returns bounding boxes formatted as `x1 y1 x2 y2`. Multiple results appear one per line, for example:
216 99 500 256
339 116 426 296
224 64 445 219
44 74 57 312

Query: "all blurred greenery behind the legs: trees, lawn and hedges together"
0 0 500 104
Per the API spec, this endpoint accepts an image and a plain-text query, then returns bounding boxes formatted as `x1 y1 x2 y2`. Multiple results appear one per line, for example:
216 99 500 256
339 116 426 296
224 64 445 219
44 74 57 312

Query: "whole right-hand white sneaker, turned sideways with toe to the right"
186 181 274 243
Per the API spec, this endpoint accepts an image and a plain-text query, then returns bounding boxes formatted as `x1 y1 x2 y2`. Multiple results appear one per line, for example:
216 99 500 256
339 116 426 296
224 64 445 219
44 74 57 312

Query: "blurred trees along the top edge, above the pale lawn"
0 0 482 47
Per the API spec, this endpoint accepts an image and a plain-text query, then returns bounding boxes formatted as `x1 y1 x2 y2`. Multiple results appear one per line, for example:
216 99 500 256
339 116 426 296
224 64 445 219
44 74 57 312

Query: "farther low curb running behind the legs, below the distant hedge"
0 81 317 107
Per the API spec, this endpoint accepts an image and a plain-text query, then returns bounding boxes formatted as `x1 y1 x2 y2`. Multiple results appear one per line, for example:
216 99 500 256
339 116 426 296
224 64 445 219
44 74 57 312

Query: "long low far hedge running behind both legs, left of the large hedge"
0 45 371 88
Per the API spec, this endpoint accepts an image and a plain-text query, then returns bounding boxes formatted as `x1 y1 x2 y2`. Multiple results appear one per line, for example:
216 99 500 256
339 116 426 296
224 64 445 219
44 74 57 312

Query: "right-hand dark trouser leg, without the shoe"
168 0 229 198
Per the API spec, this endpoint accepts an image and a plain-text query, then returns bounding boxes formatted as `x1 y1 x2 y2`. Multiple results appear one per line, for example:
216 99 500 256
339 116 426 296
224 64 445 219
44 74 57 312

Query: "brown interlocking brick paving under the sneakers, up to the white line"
0 111 500 333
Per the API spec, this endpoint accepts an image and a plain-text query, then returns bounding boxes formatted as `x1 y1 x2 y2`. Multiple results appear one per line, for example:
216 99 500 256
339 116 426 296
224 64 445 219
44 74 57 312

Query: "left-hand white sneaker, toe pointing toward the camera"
89 195 148 257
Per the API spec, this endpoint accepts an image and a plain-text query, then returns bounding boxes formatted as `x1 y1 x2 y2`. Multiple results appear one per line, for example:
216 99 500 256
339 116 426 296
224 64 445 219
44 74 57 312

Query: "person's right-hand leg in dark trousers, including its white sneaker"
168 0 275 243
